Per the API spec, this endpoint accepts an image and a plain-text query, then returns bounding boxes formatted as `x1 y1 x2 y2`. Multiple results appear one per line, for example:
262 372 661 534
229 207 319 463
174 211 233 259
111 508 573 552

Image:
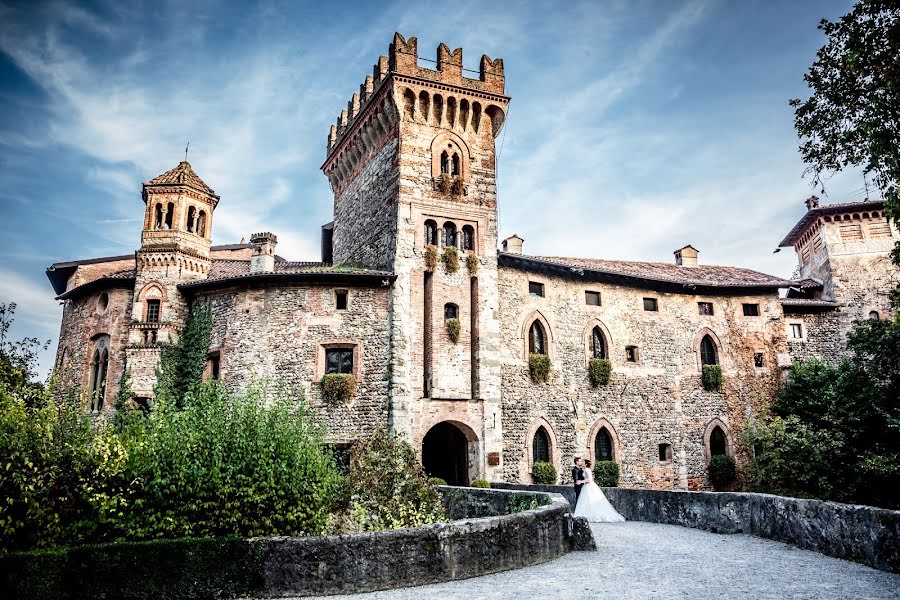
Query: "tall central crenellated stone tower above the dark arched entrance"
322 33 509 481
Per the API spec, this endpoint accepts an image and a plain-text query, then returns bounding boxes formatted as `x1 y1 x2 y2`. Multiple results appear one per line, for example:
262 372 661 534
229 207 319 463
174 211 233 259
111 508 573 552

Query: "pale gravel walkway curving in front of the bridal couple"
312 522 900 600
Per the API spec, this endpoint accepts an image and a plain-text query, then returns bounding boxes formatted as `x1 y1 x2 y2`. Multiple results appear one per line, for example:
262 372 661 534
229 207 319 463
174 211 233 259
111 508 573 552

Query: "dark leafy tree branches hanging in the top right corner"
790 0 900 292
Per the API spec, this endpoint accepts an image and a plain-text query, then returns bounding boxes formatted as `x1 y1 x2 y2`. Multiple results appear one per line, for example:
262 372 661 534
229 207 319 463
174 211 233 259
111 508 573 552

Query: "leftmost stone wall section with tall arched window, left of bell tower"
54 281 133 408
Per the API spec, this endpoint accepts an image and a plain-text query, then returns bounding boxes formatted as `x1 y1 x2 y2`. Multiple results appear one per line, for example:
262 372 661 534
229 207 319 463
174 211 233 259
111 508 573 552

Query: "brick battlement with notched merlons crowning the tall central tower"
326 33 505 153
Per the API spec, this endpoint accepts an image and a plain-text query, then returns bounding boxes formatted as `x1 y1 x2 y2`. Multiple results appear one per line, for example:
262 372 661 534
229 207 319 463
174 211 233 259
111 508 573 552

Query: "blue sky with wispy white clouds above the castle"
0 0 877 376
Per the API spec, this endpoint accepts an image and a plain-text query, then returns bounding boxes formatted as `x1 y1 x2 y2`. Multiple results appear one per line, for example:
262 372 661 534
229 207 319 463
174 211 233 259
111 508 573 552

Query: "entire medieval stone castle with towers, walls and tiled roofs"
47 34 898 489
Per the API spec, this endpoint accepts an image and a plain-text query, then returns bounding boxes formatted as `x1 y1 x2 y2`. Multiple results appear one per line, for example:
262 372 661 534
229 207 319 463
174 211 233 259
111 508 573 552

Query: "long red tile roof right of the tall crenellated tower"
516 254 791 288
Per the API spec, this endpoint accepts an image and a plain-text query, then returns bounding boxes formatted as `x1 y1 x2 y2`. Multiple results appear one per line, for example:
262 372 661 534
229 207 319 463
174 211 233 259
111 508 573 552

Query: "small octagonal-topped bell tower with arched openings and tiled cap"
126 161 219 397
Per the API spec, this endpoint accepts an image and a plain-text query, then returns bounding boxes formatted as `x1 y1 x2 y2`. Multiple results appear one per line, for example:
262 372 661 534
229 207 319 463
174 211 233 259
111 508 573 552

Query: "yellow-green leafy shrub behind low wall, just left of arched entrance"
345 430 446 531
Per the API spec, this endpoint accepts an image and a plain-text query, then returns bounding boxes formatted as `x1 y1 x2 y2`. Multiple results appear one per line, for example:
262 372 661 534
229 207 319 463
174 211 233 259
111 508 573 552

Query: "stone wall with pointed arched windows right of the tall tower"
499 267 785 489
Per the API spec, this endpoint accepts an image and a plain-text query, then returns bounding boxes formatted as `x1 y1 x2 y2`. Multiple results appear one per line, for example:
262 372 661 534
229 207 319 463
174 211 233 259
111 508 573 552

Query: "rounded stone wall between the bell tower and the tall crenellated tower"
199 285 390 442
